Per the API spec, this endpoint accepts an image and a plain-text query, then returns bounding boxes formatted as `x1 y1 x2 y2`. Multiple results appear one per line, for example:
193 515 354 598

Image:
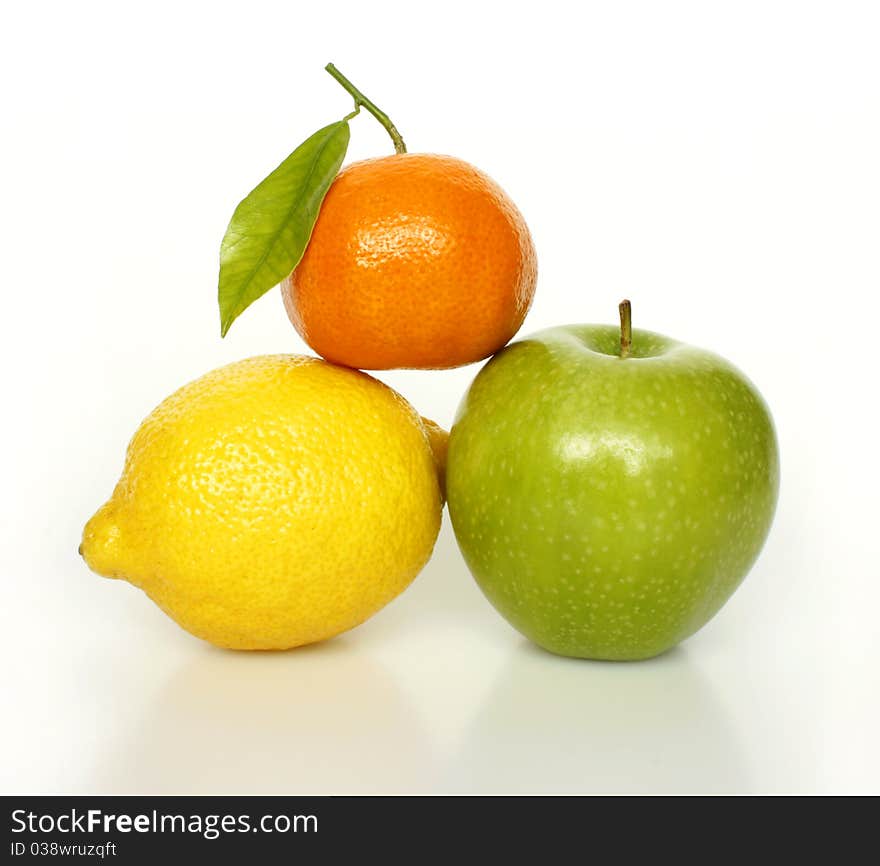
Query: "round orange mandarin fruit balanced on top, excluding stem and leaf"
282 153 537 370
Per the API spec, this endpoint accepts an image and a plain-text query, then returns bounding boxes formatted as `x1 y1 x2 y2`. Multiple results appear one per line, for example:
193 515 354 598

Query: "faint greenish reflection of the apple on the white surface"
443 641 749 794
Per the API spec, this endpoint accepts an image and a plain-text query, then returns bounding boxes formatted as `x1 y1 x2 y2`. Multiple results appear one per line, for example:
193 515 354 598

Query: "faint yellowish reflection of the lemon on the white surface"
92 639 431 794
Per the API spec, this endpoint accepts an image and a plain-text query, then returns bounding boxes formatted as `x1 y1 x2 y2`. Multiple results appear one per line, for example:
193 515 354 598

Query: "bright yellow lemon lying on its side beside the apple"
80 355 445 650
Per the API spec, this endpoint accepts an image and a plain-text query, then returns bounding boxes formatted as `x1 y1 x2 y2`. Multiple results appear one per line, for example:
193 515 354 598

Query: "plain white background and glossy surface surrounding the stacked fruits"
0 0 880 793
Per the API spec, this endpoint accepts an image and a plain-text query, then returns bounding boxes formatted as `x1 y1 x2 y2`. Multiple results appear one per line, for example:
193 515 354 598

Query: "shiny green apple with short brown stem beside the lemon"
446 301 779 660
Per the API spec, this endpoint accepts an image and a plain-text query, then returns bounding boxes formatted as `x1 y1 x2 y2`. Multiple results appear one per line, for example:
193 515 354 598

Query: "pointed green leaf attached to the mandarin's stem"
217 120 350 337
